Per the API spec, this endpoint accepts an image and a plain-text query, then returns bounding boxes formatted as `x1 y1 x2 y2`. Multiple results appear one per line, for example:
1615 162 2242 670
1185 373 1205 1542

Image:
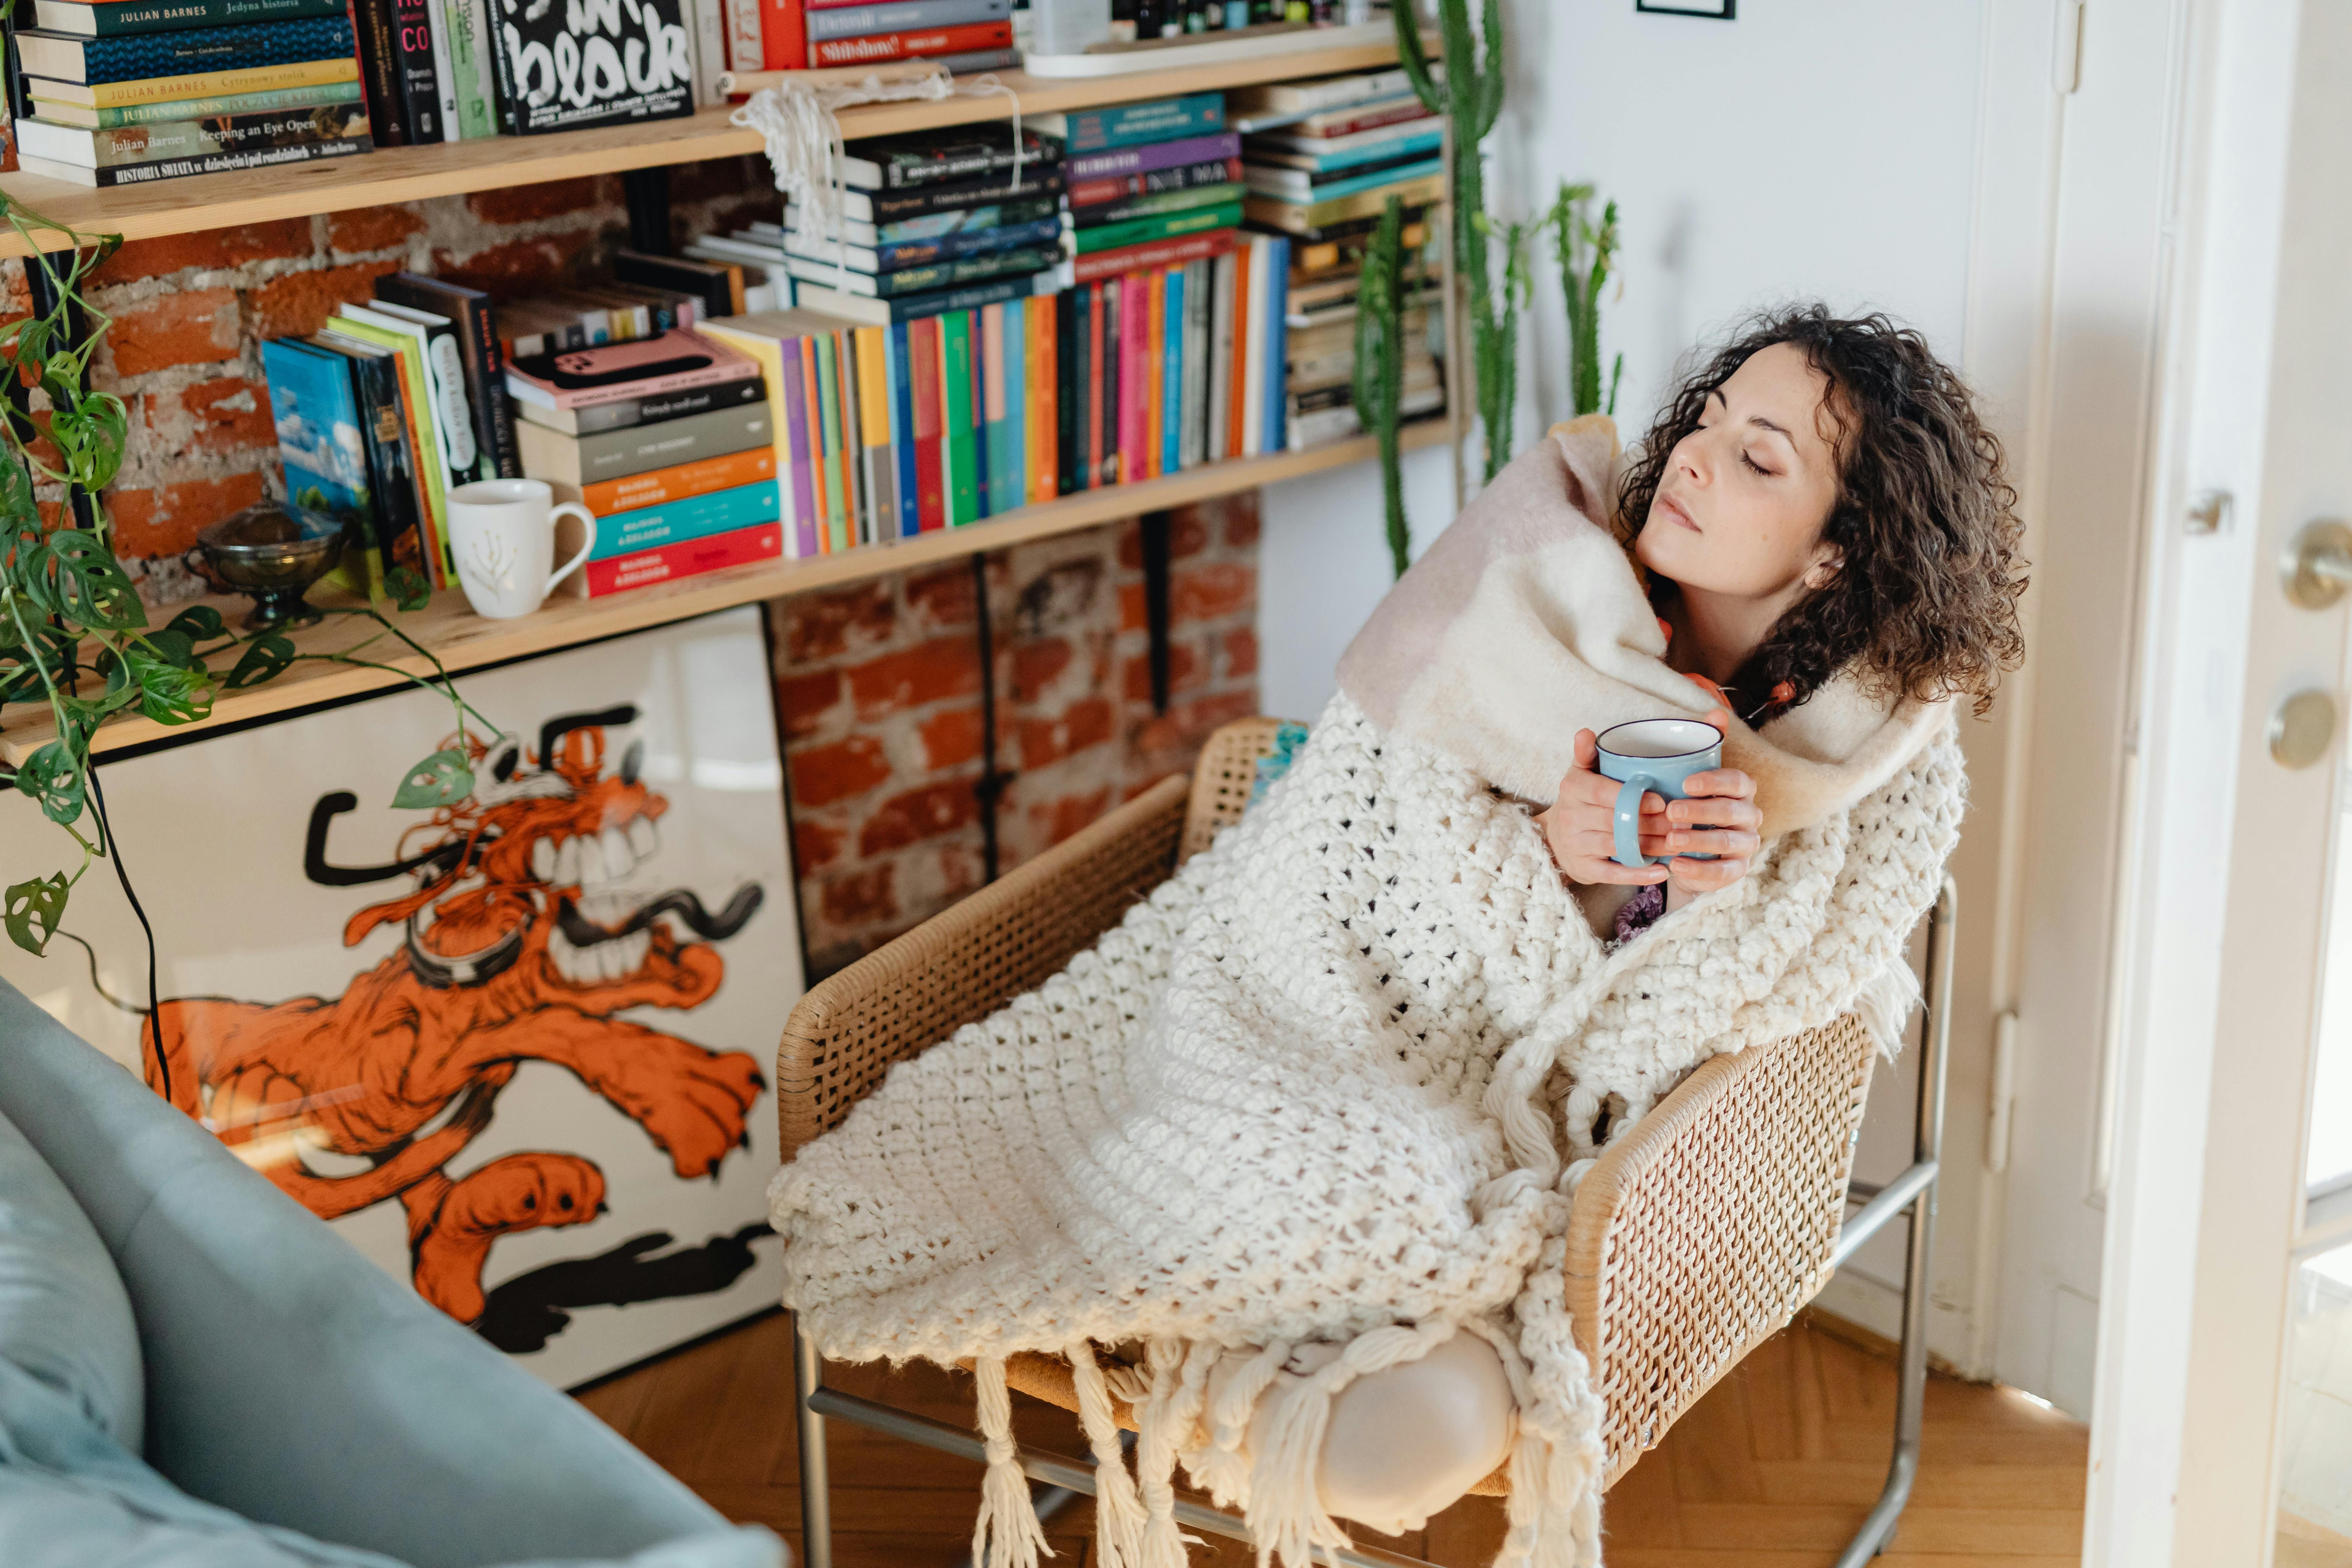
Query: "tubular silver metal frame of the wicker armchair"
793 738 1959 1568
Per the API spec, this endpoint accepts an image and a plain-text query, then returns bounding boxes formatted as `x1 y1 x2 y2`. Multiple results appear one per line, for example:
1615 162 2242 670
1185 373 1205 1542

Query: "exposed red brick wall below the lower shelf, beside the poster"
769 493 1258 978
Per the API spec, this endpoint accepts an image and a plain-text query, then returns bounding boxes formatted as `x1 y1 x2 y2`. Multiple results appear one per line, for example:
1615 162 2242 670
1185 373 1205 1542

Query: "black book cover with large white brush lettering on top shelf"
489 0 694 136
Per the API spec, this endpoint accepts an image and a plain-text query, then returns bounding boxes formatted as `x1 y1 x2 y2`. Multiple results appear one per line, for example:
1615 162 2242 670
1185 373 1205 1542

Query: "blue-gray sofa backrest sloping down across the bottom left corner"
0 983 785 1568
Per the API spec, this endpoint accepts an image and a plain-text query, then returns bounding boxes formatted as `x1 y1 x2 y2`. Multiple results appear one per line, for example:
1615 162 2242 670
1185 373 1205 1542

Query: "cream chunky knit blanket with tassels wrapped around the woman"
771 426 1964 1568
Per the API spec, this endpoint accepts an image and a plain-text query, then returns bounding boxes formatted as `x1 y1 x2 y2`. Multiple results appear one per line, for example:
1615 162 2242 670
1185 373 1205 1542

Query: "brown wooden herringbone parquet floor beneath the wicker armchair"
581 1316 2088 1568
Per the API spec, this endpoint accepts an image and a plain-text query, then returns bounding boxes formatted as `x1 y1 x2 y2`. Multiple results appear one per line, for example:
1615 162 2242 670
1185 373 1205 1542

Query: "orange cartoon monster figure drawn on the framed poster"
144 708 767 1342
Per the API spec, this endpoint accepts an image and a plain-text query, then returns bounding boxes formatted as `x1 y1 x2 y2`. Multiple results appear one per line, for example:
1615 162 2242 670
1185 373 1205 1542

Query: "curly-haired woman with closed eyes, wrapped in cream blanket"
771 306 2023 1568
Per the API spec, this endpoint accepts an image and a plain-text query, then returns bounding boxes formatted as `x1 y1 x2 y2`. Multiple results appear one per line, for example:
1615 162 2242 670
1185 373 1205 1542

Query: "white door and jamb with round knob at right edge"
2086 0 2352 1568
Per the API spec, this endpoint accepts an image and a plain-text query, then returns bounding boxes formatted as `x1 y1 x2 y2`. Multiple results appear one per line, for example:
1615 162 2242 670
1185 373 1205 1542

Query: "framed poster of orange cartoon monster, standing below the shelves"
0 609 802 1387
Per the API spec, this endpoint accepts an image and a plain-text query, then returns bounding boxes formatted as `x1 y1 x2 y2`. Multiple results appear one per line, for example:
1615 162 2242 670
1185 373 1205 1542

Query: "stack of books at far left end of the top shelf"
12 0 374 186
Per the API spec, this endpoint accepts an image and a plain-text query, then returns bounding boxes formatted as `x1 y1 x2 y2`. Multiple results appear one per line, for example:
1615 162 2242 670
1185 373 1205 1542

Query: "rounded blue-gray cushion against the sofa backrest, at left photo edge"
0 1091 146 1448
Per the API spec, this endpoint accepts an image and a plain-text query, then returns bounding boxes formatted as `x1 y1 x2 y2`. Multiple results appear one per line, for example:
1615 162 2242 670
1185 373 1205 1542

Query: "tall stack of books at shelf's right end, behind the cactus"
1232 70 1444 447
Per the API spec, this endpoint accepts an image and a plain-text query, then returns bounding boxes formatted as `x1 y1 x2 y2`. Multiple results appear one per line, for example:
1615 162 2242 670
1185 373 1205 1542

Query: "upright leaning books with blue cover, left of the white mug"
261 273 522 593
